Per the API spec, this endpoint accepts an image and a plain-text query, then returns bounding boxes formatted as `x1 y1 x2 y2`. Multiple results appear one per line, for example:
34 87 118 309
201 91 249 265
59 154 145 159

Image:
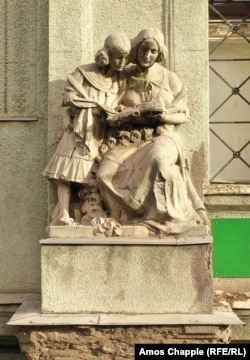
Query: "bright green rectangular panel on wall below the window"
212 218 250 277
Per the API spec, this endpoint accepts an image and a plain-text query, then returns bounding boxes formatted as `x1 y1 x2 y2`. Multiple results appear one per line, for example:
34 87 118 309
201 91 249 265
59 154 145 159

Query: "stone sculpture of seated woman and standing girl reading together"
44 28 209 236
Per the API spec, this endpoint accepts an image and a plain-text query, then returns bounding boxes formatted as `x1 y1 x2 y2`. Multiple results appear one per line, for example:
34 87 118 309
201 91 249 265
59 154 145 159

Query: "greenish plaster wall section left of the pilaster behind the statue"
0 0 48 293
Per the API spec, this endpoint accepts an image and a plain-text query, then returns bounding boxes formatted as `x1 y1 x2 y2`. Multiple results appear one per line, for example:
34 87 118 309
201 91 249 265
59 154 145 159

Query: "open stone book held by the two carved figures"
106 99 165 127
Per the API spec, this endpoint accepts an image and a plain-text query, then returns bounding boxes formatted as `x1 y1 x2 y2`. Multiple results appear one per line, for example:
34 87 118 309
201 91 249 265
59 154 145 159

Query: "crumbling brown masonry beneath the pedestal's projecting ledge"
18 325 231 360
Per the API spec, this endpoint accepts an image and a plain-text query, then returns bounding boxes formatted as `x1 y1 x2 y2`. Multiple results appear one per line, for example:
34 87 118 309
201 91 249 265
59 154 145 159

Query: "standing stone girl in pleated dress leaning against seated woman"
43 33 130 225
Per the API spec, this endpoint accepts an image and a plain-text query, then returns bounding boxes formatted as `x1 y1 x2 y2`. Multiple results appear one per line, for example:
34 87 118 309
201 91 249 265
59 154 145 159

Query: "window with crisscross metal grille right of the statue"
209 0 250 184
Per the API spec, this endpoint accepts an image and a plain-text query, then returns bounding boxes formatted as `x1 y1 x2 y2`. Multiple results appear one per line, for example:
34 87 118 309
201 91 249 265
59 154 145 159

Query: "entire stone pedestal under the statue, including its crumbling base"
8 227 242 360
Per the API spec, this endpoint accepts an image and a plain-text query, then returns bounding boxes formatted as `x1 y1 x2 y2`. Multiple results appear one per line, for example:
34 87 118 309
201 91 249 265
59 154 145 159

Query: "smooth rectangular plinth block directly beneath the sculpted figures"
40 236 213 314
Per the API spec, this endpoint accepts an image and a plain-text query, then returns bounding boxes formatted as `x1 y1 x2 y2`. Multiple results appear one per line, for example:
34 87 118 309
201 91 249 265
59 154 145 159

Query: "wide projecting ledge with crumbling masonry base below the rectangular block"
8 301 243 360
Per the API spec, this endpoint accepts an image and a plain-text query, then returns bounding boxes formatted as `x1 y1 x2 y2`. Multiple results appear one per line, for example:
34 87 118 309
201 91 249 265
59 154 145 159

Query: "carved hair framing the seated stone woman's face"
129 27 168 64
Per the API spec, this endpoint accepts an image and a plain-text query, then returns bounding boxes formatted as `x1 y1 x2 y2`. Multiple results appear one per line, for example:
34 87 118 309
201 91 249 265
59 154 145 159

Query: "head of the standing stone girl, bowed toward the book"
95 32 131 71
